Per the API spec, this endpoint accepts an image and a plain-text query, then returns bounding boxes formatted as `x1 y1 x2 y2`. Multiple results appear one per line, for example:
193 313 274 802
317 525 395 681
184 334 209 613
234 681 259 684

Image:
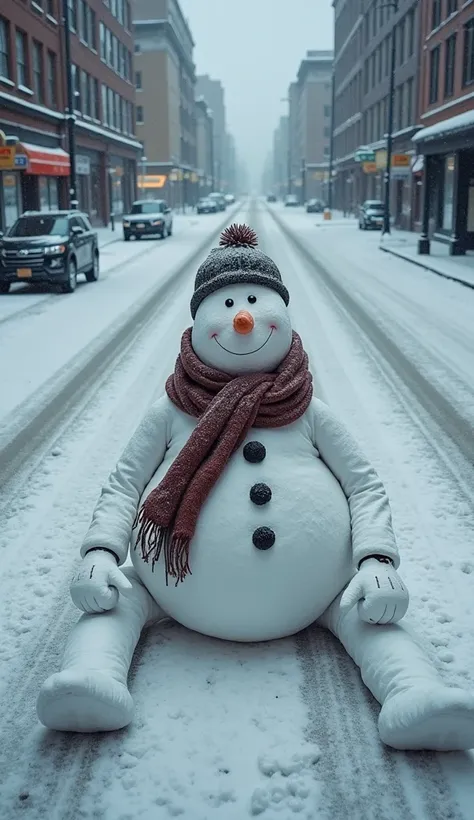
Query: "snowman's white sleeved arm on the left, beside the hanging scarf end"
81 395 171 565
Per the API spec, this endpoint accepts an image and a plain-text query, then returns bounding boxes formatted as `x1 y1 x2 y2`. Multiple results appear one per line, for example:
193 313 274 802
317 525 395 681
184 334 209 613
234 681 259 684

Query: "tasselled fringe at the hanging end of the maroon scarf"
132 507 192 587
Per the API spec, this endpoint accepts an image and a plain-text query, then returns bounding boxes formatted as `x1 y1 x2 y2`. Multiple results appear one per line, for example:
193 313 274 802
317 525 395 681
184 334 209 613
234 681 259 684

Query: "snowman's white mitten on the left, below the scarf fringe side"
70 550 132 615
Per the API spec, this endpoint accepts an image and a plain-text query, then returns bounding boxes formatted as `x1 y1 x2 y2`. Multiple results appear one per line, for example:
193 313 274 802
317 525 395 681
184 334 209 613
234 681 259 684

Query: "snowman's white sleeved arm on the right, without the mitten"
310 399 400 570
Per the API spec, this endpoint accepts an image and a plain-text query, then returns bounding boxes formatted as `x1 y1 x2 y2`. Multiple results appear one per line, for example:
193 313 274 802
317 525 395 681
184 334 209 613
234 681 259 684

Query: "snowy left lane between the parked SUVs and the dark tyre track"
0 208 237 430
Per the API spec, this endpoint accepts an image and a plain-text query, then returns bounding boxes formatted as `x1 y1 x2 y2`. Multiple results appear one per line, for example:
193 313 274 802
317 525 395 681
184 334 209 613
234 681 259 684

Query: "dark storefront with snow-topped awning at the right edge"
414 111 474 256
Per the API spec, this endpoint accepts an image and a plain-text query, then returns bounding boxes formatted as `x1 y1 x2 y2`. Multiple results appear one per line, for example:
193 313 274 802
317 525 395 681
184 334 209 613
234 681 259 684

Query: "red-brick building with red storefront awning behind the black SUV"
0 0 141 227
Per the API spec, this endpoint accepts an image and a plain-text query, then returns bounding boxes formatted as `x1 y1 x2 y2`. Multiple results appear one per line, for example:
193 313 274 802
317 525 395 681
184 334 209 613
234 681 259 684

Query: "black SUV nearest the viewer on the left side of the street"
0 211 99 293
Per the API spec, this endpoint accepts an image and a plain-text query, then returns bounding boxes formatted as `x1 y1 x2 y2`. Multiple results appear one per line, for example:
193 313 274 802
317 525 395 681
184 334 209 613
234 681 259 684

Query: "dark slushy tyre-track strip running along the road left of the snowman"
0 204 242 484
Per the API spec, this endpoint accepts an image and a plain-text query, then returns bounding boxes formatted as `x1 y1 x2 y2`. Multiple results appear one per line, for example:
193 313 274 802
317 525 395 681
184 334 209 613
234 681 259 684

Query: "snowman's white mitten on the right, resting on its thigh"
341 558 409 624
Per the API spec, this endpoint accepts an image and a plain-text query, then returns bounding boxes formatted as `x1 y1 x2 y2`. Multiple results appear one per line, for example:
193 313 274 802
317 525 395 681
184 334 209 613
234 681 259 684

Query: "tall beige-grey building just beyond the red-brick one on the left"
132 0 199 207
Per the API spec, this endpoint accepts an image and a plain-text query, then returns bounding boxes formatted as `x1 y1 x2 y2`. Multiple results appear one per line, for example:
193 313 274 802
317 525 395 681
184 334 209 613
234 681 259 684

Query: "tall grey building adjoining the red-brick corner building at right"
333 0 420 228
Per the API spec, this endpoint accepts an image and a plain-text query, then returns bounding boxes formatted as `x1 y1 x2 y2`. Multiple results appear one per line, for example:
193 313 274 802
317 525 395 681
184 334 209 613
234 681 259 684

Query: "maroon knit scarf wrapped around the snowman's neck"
133 328 313 586
